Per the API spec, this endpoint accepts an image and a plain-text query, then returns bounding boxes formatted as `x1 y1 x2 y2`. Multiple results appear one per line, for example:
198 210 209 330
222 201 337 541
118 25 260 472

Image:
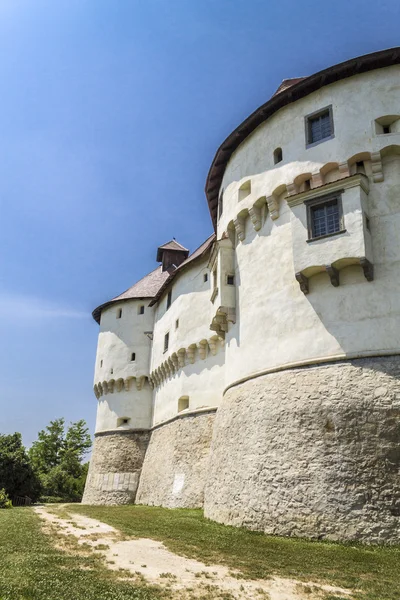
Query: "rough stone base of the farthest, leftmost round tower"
82 431 149 505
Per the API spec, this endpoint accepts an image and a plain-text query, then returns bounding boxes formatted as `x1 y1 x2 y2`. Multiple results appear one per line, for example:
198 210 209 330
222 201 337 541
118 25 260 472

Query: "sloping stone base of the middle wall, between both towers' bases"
136 412 215 508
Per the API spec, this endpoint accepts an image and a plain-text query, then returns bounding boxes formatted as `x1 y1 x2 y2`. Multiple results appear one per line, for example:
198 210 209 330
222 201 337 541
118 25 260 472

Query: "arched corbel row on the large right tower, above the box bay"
227 152 384 242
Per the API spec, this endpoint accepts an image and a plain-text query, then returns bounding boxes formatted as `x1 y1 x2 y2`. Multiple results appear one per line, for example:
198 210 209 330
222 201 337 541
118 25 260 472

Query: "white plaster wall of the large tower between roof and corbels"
218 65 400 238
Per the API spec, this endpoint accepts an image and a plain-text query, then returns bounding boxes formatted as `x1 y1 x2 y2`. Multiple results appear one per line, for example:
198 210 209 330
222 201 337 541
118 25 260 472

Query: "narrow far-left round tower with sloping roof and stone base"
82 267 168 504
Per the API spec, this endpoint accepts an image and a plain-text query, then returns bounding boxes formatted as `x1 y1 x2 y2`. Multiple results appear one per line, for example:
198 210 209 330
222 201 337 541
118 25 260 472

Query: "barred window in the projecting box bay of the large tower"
306 196 344 239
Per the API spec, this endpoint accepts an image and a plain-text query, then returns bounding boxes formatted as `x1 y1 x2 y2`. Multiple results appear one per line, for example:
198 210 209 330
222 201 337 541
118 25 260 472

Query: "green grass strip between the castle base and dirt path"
68 505 400 600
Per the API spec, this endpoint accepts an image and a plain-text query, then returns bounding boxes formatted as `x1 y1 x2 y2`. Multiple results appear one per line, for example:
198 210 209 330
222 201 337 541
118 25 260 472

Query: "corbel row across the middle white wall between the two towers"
149 335 224 388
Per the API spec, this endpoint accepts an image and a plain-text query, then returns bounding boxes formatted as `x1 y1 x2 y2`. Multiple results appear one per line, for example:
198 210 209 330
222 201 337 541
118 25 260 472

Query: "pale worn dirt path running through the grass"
35 506 351 600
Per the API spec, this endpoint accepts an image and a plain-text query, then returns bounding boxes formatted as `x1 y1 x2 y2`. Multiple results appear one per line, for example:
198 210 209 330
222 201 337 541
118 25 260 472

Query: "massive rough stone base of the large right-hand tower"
205 356 400 543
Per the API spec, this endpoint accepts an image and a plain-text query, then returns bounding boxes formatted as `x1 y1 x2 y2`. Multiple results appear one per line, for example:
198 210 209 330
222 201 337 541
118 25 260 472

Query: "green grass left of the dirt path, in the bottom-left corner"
0 508 164 600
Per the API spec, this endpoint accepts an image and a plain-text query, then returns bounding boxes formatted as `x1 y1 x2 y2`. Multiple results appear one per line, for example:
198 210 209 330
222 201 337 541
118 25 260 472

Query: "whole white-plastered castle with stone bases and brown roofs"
83 48 400 543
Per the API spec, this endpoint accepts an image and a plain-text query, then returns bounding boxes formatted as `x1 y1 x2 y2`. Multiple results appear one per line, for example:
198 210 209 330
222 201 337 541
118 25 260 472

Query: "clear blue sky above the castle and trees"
0 0 400 445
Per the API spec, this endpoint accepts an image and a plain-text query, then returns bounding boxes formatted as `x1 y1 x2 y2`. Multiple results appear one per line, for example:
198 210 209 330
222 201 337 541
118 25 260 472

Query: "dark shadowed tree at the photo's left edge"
0 433 41 501
